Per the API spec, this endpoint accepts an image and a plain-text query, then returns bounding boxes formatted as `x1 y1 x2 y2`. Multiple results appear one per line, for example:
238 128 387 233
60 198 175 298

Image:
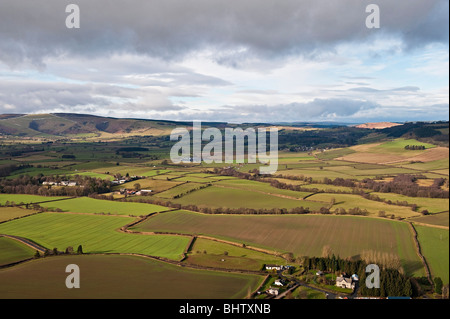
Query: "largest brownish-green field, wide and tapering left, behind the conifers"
134 211 423 273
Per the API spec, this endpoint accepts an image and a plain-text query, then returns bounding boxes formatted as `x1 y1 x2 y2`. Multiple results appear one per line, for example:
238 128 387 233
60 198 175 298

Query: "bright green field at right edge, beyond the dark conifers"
414 225 449 284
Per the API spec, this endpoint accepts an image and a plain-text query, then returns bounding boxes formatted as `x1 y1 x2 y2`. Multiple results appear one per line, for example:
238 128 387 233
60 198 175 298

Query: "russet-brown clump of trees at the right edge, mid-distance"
360 174 449 198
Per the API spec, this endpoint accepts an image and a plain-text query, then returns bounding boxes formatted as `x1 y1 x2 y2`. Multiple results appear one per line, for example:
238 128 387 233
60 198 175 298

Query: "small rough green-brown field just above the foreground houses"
186 238 286 270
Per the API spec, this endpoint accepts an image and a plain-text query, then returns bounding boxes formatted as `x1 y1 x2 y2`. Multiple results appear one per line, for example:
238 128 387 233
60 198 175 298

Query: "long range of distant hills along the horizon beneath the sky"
0 113 449 148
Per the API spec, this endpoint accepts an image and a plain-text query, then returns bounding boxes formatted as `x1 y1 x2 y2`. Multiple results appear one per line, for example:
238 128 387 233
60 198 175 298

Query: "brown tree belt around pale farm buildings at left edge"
0 174 111 196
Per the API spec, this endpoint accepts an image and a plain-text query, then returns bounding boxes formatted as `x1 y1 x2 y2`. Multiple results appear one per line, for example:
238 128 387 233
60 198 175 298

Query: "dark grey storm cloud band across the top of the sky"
0 0 448 68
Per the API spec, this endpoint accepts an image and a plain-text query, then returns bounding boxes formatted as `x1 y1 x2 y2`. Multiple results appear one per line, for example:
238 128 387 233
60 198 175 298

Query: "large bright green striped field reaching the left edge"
0 213 189 260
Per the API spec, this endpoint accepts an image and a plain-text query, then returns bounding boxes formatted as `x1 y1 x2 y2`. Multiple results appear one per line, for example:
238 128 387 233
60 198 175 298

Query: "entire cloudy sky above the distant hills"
0 0 449 123
